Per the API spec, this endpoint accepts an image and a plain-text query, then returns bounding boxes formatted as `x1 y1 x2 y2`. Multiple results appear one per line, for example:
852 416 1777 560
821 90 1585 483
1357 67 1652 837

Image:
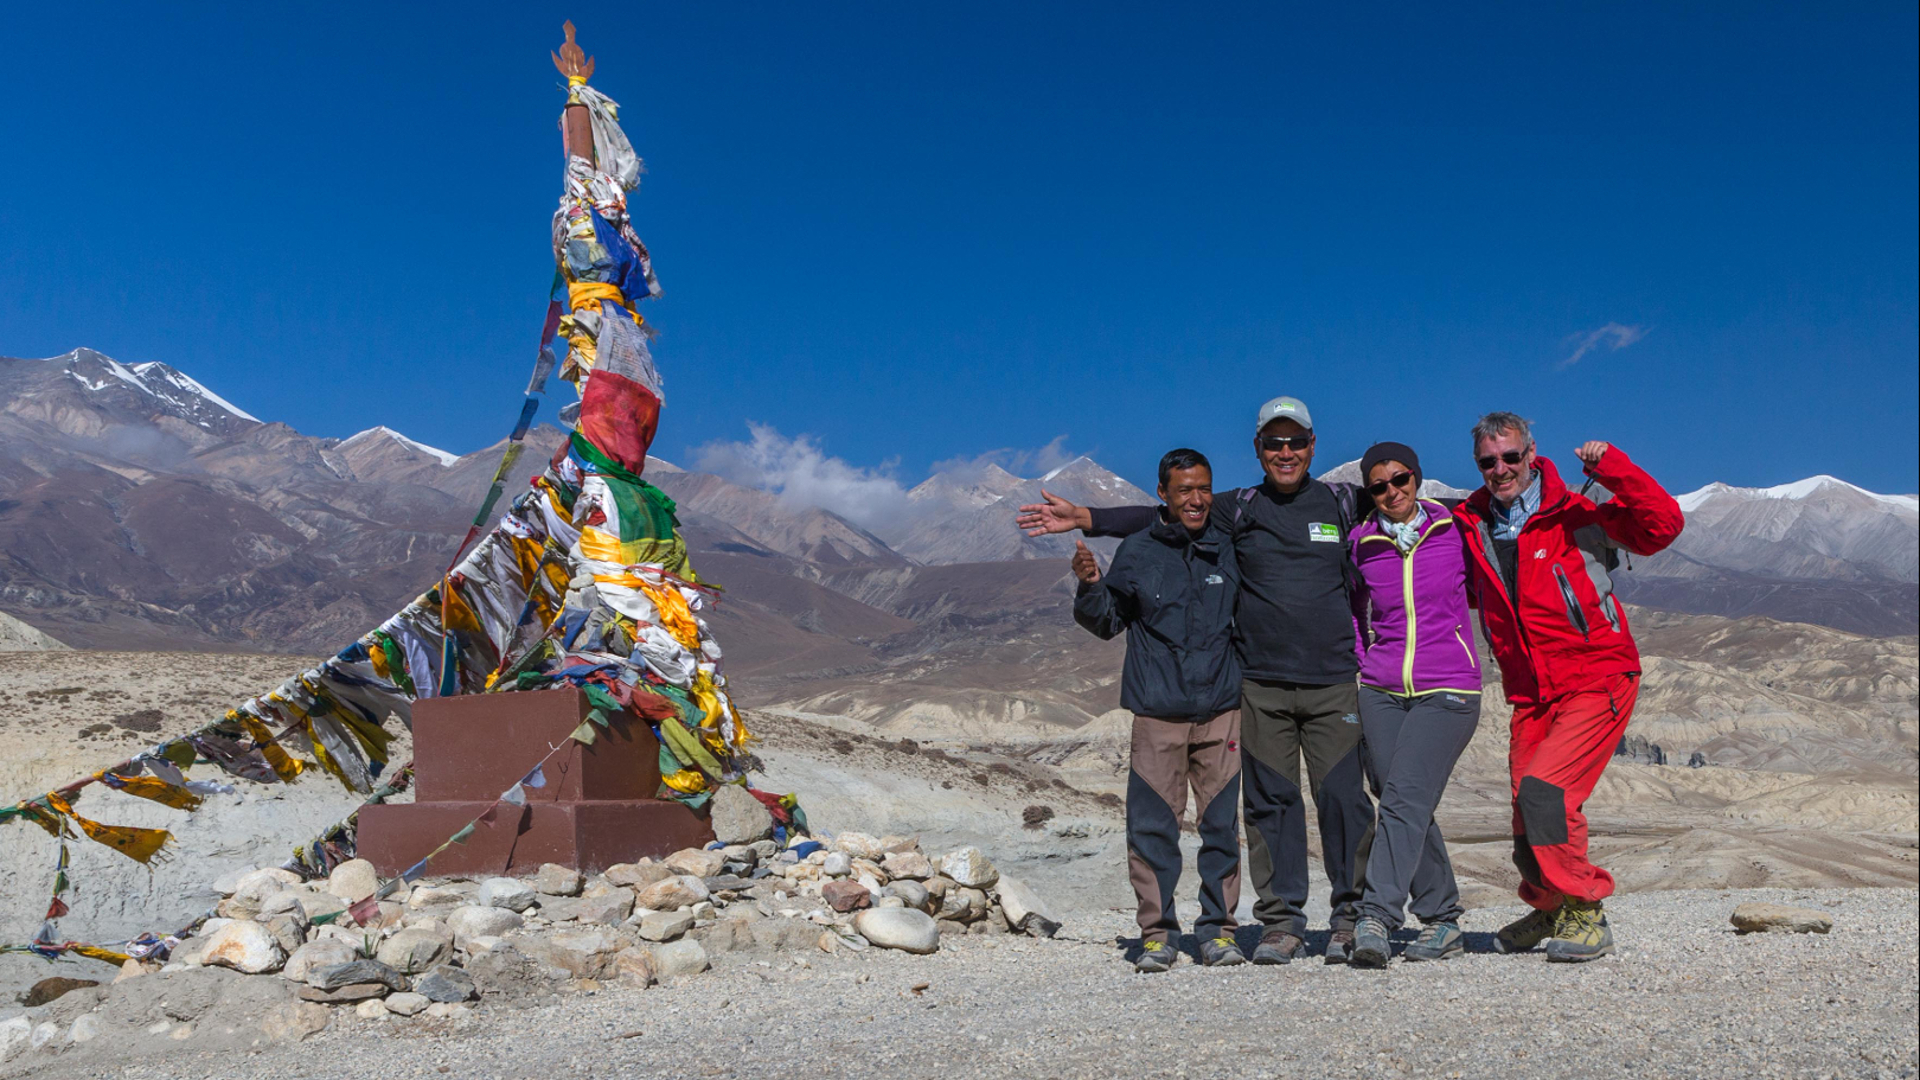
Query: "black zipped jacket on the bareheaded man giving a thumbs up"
1073 507 1240 721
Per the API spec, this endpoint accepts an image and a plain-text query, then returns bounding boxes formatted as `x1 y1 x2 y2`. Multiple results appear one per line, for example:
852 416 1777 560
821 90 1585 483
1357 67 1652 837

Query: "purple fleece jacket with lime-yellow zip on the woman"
1352 500 1480 694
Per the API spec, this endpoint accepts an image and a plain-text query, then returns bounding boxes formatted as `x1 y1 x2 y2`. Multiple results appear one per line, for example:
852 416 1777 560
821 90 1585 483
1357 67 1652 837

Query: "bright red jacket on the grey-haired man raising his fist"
1453 446 1686 703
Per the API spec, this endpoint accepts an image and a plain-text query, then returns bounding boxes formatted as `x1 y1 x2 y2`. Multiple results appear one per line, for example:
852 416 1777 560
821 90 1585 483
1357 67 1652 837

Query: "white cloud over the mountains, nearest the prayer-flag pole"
695 423 910 530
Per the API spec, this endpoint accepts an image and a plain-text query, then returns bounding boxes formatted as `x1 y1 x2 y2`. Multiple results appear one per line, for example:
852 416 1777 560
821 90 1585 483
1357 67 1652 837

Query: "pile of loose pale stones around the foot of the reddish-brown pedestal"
13 832 1060 1049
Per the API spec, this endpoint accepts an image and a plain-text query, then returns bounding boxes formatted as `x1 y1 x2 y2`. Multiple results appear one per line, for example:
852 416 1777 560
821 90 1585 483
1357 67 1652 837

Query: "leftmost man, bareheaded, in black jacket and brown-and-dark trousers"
1073 450 1246 972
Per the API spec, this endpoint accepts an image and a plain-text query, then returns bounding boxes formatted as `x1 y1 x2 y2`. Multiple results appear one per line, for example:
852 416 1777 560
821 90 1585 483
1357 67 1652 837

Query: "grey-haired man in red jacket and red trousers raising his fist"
1455 413 1686 961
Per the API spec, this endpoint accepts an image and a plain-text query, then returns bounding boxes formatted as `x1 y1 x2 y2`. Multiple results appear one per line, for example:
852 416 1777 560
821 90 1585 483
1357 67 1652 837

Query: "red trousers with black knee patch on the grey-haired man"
1507 675 1640 911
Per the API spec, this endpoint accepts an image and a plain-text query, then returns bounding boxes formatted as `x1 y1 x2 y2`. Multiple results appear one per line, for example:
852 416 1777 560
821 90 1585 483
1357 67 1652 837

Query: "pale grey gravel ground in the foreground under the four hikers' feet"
8 890 1920 1080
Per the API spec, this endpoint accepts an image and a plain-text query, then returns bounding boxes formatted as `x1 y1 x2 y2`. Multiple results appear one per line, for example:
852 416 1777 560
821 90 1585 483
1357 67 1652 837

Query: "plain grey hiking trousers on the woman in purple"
1357 686 1480 930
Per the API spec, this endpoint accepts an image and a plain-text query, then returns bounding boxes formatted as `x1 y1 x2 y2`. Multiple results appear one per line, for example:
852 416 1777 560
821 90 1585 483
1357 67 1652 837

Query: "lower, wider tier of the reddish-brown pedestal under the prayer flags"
359 799 714 876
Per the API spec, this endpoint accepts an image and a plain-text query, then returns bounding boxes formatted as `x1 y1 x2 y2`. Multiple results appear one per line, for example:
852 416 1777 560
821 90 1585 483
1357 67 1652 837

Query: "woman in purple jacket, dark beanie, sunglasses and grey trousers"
1350 442 1480 967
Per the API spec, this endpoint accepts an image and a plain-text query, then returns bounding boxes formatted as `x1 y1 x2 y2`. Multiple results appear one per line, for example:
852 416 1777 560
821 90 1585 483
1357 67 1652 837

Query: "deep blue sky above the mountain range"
0 2 1920 492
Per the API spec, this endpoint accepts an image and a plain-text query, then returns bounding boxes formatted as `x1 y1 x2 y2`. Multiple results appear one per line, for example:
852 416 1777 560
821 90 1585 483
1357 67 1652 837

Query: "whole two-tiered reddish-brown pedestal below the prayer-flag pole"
359 688 714 876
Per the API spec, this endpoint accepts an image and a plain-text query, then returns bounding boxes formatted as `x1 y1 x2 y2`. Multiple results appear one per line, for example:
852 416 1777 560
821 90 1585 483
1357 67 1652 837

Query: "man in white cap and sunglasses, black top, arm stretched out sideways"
1018 398 1373 963
